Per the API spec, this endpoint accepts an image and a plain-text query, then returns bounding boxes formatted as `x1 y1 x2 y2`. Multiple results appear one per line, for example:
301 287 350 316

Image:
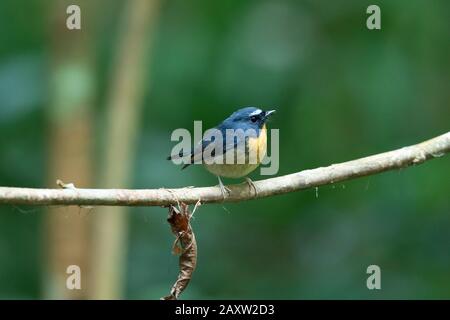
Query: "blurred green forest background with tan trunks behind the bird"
0 0 450 299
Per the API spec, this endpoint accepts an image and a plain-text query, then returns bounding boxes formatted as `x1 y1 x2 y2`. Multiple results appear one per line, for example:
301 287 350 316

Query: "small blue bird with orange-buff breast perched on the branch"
167 107 276 198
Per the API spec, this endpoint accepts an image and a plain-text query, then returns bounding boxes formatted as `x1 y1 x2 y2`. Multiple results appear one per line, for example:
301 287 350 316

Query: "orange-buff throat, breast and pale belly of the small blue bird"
203 125 267 178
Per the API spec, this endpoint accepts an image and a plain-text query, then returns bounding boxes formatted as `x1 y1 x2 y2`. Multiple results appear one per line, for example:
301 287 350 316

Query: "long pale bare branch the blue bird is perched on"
0 132 450 206
